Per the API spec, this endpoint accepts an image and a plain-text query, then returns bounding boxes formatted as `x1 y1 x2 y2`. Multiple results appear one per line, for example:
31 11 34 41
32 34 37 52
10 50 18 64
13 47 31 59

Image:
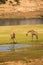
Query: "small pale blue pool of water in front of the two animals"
0 44 31 51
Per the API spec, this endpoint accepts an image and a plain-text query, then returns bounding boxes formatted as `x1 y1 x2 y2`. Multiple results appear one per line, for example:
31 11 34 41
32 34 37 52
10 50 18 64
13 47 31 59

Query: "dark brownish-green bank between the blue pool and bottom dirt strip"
0 45 43 63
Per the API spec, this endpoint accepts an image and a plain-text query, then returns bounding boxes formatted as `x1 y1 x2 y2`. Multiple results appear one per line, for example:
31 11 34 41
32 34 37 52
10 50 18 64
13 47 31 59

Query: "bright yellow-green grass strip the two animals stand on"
0 24 43 44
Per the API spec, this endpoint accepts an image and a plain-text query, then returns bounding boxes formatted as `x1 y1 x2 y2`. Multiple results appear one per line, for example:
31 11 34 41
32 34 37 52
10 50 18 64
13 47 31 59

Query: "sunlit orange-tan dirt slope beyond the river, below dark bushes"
0 0 43 18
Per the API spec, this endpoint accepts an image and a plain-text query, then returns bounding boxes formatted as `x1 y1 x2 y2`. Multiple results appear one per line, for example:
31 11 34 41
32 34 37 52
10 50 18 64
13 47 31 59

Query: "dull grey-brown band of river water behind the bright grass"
0 18 43 26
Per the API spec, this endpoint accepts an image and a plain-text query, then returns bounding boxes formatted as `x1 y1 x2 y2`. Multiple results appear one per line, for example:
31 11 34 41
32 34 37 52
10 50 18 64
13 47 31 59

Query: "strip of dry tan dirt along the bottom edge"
0 59 43 65
